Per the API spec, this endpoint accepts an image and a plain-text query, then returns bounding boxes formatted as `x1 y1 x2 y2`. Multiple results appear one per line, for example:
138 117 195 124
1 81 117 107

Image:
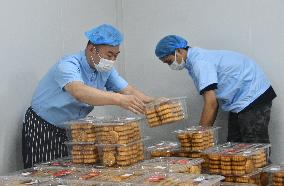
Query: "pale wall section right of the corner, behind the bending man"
122 0 284 163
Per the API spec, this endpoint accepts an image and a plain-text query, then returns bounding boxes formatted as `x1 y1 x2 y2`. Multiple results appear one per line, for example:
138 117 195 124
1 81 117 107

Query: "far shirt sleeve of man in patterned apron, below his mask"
106 68 128 92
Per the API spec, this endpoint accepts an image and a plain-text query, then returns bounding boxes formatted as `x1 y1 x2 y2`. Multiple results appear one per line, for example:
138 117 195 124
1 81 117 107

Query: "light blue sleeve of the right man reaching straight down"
193 60 218 93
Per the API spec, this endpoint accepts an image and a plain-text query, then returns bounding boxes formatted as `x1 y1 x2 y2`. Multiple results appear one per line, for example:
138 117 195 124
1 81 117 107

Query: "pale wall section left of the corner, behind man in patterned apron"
0 0 117 174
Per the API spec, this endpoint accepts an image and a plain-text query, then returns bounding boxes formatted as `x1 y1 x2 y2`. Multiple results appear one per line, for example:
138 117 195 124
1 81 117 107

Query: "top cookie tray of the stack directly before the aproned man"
65 117 144 144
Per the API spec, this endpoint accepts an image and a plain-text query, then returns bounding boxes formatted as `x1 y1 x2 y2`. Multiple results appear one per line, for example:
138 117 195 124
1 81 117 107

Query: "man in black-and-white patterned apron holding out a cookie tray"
22 24 153 168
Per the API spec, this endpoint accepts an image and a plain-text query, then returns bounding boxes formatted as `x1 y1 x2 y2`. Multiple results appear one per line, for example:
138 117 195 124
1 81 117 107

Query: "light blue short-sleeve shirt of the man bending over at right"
186 48 271 113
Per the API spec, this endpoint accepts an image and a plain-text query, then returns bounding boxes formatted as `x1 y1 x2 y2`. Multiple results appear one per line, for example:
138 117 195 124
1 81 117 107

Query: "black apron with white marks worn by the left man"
22 108 68 168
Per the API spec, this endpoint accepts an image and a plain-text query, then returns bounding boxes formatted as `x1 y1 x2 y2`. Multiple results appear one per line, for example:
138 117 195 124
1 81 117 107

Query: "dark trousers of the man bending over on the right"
227 101 272 143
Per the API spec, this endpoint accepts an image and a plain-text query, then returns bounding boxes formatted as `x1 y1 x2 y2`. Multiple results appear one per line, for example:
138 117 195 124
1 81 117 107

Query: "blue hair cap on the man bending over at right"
155 35 187 58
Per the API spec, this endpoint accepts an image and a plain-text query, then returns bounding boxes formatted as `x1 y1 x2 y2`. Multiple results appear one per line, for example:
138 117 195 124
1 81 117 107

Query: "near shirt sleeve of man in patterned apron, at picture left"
54 58 84 90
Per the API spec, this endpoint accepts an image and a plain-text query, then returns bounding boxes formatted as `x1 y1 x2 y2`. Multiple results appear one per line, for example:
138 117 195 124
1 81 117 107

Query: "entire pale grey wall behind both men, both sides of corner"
0 0 284 174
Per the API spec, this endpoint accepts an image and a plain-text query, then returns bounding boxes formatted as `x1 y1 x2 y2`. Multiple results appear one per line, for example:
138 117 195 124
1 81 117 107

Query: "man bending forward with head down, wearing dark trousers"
155 35 276 143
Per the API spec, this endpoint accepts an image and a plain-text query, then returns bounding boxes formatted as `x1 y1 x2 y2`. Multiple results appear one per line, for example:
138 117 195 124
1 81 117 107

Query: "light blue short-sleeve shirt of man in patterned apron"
32 51 128 126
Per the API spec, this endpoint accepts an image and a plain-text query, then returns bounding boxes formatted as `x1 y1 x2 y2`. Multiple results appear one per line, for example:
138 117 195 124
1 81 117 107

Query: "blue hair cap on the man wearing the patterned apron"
85 24 123 46
